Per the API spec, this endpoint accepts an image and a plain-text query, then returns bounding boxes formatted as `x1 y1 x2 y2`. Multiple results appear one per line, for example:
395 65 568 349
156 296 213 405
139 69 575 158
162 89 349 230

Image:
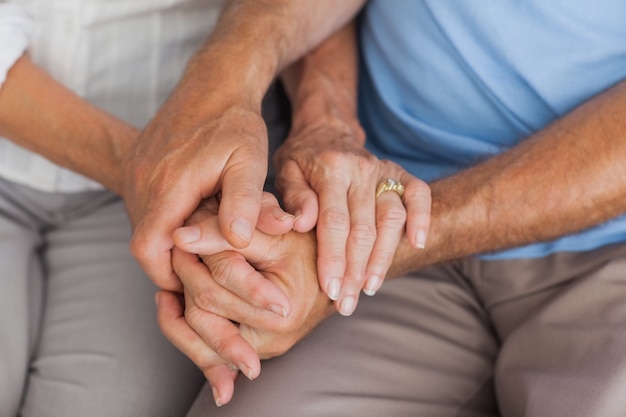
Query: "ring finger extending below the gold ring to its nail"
363 188 407 296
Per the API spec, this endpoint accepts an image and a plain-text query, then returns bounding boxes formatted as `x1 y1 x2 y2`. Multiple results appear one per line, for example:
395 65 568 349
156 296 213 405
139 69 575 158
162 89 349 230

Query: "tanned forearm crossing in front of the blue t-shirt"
389 81 626 277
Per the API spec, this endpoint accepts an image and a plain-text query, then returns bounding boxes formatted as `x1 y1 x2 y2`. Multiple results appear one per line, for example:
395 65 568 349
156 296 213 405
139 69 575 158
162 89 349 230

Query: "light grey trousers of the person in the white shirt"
0 180 204 417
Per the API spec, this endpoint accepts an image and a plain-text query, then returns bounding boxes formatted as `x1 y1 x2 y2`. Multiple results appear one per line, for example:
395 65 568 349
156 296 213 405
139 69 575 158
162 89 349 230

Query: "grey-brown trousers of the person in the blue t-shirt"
189 239 626 417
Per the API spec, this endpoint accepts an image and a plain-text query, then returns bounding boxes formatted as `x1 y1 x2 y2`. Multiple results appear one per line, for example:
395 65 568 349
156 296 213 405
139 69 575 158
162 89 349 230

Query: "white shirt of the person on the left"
0 0 223 192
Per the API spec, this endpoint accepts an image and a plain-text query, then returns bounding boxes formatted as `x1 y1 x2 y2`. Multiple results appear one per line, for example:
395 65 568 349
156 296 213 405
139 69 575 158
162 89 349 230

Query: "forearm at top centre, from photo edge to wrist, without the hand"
169 0 364 114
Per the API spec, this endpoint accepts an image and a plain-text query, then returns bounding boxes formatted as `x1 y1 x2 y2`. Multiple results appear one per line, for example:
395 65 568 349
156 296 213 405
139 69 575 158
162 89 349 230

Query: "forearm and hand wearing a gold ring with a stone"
275 23 430 315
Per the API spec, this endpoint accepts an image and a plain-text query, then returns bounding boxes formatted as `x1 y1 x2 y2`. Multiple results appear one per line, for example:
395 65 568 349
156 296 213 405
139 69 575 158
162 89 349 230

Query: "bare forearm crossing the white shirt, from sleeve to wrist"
0 56 138 192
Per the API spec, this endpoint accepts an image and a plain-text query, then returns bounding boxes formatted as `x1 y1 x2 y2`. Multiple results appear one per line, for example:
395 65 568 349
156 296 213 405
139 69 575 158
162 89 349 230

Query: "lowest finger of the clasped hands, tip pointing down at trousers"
156 291 236 406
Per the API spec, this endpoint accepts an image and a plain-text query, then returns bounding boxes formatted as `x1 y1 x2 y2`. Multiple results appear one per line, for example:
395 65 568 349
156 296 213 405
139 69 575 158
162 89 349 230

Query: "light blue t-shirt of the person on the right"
359 0 626 258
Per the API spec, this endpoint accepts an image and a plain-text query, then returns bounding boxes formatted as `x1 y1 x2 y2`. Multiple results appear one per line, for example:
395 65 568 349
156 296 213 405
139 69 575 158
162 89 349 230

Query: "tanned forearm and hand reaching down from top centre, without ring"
124 0 363 288
